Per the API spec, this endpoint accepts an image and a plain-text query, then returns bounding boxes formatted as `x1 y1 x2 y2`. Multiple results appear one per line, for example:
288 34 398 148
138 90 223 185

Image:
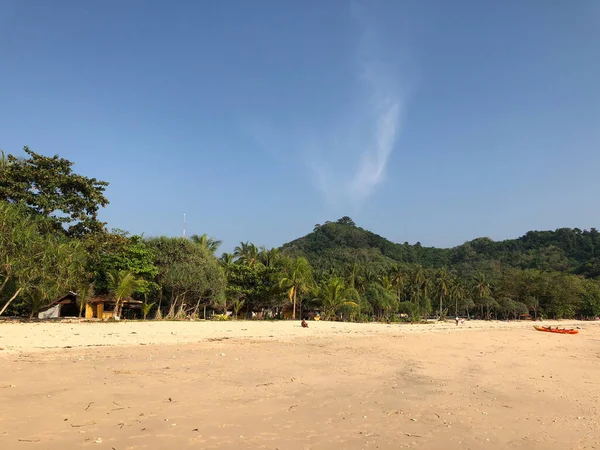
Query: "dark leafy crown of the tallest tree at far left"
0 147 108 236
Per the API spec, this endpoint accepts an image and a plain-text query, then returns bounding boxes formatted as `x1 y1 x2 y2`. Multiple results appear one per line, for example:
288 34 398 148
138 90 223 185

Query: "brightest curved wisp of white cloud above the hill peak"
307 12 405 209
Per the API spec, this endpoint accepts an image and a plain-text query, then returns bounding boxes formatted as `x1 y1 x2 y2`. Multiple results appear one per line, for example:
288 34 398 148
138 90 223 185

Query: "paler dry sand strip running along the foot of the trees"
0 320 600 358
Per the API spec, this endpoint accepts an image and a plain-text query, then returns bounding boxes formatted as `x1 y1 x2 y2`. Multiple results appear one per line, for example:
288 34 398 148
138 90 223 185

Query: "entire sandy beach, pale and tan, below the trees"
0 322 600 450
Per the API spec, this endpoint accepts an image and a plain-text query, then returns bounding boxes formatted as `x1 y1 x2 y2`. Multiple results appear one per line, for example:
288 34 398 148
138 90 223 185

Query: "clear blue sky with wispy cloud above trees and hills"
0 0 600 250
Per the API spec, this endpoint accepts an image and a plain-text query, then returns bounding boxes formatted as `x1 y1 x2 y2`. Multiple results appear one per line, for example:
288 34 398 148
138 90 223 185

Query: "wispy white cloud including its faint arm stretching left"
241 4 408 211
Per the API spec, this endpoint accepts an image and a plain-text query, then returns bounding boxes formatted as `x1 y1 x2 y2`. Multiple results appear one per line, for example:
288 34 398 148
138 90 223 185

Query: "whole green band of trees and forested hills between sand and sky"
0 148 600 321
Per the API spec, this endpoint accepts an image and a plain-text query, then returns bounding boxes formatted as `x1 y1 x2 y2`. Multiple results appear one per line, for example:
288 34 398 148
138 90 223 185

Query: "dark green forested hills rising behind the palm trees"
282 217 600 277
